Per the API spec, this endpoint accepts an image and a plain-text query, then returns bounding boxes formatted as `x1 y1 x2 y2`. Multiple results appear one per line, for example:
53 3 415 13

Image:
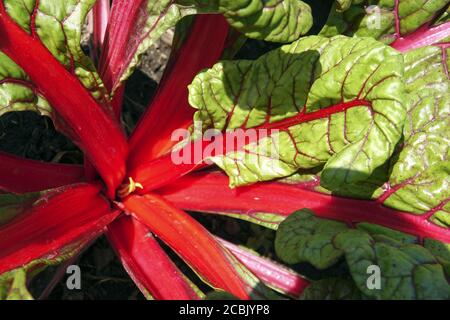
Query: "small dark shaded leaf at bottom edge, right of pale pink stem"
300 278 362 300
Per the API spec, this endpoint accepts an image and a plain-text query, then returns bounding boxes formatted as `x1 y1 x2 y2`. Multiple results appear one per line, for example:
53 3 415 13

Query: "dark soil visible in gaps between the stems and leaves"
0 0 347 300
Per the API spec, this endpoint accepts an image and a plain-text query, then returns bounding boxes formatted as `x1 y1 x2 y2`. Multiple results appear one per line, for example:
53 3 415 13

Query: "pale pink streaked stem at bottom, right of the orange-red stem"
217 238 309 298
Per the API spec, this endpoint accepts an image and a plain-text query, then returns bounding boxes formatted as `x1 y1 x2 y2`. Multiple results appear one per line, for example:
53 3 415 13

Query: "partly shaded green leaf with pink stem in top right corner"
320 0 450 51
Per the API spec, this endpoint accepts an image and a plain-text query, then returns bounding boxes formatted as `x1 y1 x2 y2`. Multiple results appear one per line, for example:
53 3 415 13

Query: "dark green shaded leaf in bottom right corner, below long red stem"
275 209 450 299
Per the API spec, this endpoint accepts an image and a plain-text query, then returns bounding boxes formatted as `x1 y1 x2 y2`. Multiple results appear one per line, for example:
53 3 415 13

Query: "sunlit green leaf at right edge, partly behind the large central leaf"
268 45 450 202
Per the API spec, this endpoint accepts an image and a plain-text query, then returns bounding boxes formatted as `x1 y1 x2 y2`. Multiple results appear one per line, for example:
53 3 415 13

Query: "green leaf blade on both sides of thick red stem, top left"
0 0 108 116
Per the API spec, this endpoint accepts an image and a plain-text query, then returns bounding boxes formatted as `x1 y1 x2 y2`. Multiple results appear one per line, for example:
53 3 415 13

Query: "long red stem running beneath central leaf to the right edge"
159 173 450 243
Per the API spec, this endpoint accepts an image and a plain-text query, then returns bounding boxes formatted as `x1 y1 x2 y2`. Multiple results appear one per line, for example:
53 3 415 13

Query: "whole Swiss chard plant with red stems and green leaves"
0 0 450 299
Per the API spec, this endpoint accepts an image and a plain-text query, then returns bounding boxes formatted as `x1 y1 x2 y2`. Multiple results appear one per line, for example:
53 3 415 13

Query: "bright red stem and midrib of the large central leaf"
128 99 371 194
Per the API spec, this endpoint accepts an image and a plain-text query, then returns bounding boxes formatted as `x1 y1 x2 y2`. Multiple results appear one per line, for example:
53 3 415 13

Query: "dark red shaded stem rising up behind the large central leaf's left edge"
128 15 229 169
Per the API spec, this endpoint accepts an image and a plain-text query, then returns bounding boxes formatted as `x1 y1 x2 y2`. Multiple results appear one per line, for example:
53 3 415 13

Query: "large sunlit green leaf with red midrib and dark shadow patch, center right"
189 36 405 190
